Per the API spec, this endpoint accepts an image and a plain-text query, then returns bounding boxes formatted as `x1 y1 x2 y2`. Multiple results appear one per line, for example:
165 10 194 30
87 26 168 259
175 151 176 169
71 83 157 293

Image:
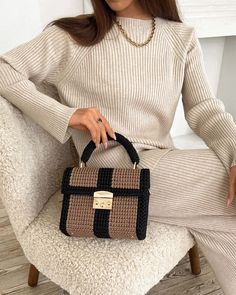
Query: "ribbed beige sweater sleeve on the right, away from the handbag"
182 28 236 173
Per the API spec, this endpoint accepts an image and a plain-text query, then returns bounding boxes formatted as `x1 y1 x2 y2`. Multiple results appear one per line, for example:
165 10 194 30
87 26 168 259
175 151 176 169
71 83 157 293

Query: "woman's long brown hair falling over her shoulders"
46 0 182 46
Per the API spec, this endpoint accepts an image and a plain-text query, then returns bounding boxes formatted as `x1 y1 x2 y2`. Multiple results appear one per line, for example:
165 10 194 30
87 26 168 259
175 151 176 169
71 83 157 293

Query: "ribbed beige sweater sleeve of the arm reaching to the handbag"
0 25 77 143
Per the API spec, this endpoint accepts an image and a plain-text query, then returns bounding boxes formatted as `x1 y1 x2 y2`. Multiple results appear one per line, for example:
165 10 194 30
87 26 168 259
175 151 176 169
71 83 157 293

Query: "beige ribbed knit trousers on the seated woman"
87 145 236 295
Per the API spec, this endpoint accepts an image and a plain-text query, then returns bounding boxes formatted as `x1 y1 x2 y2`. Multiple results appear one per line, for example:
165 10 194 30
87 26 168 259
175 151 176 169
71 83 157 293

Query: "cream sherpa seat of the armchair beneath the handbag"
20 190 194 295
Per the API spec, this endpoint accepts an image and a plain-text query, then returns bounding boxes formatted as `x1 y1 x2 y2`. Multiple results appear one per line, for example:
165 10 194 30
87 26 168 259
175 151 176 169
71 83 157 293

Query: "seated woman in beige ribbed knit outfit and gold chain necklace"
0 0 236 295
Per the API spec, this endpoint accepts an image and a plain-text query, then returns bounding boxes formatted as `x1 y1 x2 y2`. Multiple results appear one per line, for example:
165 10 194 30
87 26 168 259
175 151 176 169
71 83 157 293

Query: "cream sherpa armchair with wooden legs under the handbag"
0 96 200 295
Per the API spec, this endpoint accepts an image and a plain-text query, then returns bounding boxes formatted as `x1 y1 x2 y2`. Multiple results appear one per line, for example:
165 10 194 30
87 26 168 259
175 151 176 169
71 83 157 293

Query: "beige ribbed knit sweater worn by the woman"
0 16 236 170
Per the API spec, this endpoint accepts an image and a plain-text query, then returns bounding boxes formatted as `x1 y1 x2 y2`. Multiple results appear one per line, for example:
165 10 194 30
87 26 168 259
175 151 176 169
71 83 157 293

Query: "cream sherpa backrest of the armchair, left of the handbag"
0 96 73 236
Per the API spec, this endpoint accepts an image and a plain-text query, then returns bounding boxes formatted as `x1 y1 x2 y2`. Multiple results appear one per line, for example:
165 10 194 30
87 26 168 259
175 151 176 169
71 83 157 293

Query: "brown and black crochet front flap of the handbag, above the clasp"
61 166 150 196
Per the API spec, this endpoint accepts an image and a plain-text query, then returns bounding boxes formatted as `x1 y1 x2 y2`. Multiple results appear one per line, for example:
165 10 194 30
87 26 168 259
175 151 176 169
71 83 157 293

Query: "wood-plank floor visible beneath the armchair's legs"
0 199 223 295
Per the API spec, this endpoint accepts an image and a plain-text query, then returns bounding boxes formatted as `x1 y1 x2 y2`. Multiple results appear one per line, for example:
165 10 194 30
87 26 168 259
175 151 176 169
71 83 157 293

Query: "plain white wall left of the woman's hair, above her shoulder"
0 0 84 54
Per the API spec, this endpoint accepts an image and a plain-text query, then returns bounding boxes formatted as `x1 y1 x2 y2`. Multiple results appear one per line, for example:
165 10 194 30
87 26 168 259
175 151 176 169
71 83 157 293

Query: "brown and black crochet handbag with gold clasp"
59 132 150 240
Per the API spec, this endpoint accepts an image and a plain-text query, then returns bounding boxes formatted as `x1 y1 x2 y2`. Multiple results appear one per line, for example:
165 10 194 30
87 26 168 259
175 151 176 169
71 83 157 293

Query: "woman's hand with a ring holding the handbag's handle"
69 107 116 148
